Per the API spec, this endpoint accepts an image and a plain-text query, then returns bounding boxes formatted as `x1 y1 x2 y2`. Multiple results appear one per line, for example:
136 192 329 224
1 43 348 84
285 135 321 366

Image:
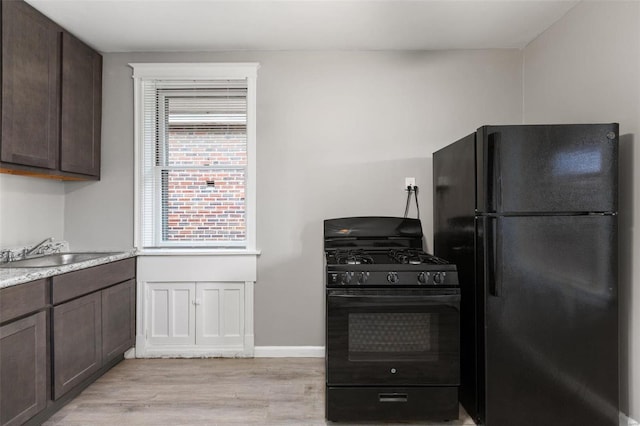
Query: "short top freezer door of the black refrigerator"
476 124 618 214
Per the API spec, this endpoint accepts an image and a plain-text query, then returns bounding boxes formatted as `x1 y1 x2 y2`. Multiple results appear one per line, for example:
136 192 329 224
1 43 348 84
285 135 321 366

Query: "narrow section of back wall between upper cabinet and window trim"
65 55 134 250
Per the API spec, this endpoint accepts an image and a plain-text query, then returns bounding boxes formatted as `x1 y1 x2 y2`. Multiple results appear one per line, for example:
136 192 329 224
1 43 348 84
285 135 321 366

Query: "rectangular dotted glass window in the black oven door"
349 312 438 361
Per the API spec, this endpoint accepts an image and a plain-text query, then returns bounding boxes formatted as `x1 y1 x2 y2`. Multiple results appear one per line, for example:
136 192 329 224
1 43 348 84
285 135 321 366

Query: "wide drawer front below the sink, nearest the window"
51 257 136 305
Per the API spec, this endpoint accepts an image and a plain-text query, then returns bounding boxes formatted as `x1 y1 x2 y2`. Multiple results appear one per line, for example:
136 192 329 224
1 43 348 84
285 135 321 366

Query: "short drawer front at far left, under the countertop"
0 279 47 323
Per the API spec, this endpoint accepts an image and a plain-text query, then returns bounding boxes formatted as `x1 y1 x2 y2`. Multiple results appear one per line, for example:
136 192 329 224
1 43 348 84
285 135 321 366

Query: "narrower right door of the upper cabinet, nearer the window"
60 32 102 177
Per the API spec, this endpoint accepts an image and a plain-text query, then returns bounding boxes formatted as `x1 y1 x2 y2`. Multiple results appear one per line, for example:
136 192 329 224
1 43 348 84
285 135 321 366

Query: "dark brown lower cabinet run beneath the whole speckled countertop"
0 258 136 426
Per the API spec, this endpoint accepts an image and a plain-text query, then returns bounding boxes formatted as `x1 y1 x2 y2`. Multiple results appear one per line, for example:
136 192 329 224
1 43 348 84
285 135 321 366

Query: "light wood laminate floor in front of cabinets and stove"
44 358 474 426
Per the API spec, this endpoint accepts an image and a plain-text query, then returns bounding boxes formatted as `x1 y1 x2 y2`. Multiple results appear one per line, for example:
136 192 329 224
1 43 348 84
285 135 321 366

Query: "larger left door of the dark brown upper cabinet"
0 1 60 169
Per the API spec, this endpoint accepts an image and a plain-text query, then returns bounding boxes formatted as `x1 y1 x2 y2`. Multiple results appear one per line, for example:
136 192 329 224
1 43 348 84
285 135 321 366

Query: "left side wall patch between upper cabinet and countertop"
0 174 64 248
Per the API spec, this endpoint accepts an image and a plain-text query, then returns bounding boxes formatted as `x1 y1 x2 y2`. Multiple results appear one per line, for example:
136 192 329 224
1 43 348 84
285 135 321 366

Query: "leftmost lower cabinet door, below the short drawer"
0 312 47 426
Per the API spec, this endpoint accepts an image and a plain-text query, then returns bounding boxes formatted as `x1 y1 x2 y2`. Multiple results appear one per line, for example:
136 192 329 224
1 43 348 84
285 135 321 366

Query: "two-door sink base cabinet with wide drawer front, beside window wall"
51 259 135 401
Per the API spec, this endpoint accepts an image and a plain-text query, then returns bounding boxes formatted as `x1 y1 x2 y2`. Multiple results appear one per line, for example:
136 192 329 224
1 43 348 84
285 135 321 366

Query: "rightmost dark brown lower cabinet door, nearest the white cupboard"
102 280 136 363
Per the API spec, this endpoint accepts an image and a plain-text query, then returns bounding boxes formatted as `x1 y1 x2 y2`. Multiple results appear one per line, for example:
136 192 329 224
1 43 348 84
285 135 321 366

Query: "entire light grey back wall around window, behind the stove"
65 50 522 346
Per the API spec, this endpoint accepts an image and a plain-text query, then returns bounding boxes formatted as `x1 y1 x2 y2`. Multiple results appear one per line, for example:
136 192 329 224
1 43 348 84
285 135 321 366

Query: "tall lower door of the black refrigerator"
484 216 619 426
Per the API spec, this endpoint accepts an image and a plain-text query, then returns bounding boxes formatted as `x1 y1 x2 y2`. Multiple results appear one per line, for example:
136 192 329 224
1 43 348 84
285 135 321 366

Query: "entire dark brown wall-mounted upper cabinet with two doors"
0 1 102 180
